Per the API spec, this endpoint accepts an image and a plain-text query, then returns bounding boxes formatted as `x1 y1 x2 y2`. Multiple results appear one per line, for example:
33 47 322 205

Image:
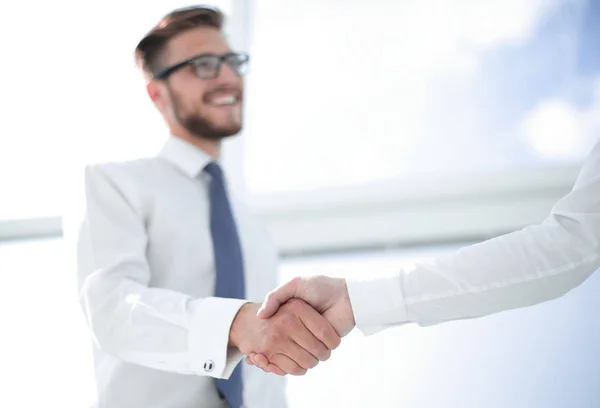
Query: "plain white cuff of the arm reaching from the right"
346 277 407 335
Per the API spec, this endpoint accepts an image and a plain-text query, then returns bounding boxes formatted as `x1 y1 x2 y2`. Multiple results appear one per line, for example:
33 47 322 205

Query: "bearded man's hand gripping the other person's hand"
229 299 341 375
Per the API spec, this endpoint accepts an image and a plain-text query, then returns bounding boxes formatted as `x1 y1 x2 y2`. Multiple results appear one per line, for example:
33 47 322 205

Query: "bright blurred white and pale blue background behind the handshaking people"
0 0 600 408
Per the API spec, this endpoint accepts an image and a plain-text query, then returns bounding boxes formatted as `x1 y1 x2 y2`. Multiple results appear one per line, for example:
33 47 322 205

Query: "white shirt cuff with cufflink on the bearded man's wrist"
189 297 248 379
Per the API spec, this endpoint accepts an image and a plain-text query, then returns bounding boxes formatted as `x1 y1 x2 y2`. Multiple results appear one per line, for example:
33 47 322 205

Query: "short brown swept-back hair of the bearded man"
135 6 224 75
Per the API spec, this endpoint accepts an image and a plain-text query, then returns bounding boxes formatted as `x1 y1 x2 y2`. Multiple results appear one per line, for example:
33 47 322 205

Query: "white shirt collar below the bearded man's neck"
159 136 213 178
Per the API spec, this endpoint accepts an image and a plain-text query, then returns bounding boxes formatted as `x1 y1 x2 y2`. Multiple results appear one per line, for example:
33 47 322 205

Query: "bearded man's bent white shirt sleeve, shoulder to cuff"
78 166 245 378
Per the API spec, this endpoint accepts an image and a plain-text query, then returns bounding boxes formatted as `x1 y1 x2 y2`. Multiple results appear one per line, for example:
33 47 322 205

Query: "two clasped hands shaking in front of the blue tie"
229 276 355 375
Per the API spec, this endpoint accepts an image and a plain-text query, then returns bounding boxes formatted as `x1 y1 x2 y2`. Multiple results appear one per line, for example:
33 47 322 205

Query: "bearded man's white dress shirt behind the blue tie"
77 137 286 408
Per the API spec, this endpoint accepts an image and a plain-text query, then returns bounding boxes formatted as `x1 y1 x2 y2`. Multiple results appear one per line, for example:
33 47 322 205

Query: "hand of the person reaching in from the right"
246 276 356 375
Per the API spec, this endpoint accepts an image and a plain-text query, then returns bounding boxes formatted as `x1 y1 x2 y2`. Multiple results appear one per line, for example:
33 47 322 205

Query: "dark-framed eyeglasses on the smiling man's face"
154 52 250 80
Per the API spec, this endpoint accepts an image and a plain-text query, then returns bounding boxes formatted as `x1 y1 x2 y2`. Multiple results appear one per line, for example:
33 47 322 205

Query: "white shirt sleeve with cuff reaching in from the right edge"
347 139 600 334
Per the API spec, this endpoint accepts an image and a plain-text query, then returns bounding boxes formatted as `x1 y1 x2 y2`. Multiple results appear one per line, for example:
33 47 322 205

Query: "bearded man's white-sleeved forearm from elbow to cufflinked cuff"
81 274 244 378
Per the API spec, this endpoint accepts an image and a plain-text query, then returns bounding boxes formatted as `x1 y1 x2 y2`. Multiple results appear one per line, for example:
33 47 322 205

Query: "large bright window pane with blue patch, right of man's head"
245 0 600 194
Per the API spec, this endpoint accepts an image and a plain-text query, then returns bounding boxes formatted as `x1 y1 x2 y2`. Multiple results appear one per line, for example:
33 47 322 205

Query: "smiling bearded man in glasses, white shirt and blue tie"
78 7 340 408
